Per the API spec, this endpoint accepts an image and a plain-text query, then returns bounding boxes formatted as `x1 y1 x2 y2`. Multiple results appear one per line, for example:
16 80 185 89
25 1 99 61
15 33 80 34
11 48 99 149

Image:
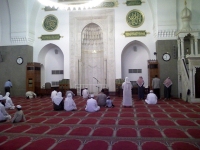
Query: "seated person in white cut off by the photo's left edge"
0 95 11 121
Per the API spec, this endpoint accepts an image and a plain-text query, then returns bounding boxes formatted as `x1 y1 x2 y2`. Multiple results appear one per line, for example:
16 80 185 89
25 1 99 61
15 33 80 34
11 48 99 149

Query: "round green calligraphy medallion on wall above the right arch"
126 9 144 28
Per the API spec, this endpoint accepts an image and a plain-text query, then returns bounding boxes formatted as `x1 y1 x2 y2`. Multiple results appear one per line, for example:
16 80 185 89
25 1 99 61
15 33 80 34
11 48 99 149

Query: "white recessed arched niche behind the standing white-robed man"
121 41 150 86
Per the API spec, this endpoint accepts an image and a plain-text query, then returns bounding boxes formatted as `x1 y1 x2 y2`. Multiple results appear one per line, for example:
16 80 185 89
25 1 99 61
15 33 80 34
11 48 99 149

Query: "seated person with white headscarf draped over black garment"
52 92 64 111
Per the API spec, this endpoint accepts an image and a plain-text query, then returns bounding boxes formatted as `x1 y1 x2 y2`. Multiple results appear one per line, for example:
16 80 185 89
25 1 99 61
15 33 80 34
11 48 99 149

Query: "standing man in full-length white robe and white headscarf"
122 77 133 107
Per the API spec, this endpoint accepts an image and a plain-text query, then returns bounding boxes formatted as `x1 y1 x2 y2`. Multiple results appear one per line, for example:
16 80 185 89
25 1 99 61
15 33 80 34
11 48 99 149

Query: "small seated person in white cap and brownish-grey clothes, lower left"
11 105 26 123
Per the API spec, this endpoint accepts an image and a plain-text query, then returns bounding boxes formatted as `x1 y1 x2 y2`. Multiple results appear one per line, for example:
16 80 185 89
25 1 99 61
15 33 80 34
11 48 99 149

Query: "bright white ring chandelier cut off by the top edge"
38 0 104 10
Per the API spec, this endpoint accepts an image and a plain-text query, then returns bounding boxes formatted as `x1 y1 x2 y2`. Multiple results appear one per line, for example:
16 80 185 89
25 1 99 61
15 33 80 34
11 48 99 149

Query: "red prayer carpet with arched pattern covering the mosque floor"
0 96 200 150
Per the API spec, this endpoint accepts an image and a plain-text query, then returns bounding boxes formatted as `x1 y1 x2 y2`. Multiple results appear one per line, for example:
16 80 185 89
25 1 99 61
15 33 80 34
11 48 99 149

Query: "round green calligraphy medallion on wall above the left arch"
43 15 58 32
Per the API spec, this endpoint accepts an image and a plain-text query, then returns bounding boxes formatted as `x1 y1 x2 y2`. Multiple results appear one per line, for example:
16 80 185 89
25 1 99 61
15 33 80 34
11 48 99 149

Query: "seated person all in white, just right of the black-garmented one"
64 92 77 111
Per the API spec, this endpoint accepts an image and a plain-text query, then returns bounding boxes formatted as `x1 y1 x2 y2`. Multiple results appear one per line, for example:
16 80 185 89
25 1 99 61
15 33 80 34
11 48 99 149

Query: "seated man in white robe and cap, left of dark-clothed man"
85 94 100 112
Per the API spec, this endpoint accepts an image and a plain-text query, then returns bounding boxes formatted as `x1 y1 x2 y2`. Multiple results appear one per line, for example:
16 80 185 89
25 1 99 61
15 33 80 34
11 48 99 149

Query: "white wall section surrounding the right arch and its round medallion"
115 0 156 79
